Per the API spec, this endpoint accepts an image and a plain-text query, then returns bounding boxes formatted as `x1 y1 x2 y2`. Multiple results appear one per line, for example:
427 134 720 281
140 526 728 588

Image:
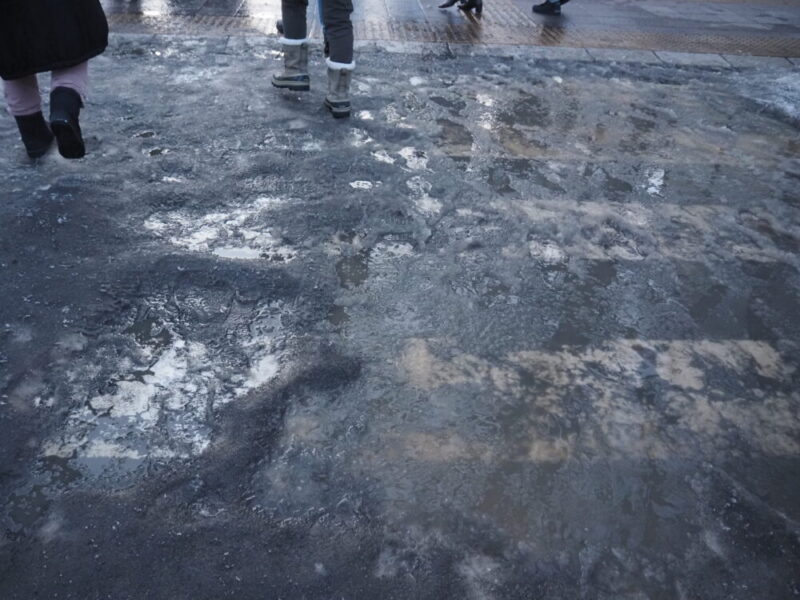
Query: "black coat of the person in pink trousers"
0 0 108 79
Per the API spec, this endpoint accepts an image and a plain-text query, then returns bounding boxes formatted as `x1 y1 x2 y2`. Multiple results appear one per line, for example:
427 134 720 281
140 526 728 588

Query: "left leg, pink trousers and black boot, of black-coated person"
3 75 53 158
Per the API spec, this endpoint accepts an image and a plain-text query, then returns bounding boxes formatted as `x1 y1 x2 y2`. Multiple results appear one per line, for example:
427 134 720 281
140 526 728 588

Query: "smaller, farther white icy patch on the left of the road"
144 197 297 262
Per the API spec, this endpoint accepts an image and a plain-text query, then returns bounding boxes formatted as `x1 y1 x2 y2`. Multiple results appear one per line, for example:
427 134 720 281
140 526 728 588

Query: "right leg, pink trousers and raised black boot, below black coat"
50 62 89 158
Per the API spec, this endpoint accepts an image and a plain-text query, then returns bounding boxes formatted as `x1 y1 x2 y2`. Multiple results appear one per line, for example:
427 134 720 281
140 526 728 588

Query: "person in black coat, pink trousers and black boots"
0 0 108 158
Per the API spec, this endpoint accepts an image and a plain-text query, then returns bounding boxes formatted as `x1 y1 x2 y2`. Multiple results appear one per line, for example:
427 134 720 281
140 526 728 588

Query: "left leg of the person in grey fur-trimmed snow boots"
272 0 310 92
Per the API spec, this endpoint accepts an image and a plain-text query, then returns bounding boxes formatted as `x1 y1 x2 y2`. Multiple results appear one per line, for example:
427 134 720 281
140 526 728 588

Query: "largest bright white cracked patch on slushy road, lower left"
41 298 283 476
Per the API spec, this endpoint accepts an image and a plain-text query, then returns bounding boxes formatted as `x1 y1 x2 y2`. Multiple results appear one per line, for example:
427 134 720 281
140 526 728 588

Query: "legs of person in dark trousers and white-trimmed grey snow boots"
272 0 356 119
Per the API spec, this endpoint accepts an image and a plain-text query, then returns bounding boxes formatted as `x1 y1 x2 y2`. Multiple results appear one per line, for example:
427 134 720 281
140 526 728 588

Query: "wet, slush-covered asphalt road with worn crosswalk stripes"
0 36 800 600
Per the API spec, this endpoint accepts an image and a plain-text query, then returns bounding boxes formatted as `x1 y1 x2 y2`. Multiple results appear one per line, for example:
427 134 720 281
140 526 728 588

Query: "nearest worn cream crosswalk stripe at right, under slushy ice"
399 339 800 463
